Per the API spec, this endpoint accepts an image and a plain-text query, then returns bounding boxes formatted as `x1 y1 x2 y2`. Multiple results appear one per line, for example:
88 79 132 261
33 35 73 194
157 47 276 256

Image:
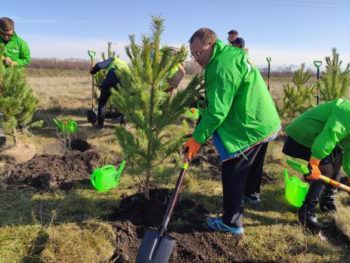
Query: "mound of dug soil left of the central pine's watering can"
6 148 99 190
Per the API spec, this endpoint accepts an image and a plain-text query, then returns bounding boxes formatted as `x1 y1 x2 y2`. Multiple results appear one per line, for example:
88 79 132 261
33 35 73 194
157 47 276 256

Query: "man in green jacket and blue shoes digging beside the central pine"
184 28 280 234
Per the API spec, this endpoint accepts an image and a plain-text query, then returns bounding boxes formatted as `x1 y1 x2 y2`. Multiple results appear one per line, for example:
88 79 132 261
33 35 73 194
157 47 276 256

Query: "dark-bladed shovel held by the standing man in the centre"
136 158 189 263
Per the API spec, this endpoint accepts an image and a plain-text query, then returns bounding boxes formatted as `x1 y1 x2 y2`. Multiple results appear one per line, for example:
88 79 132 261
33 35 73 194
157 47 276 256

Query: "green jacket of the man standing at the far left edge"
0 33 31 67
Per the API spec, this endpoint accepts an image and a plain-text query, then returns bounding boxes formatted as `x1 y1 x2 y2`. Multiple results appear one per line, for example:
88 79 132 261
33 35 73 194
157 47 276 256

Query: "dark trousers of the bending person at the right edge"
282 137 342 211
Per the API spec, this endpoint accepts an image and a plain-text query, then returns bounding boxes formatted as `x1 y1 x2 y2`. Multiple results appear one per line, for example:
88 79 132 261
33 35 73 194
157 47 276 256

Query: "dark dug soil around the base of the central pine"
108 189 245 263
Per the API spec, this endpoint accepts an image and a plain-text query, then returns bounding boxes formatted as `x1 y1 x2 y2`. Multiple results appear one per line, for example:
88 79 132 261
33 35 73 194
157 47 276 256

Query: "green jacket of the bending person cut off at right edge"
286 99 350 176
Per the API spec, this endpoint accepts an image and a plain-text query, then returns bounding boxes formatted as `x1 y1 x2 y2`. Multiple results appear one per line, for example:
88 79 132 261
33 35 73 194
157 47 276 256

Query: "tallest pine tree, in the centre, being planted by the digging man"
112 17 199 198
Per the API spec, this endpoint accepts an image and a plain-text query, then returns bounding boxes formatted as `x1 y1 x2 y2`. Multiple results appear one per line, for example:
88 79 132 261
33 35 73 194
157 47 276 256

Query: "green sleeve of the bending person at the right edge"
311 114 349 160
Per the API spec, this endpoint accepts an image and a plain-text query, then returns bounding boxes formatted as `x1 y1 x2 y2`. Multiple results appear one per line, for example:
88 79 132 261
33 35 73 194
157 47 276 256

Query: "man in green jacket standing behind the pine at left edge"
0 17 31 67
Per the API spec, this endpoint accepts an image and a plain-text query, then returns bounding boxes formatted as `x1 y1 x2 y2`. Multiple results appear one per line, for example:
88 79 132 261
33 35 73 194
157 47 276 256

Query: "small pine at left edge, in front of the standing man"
0 46 38 141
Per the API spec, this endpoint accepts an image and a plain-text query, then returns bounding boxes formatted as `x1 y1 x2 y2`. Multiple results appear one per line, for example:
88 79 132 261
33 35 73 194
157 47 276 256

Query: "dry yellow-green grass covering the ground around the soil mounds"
0 70 350 263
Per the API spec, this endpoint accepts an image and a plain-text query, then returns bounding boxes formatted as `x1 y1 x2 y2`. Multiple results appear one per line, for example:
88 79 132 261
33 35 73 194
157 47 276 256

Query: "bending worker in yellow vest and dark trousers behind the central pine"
90 57 130 129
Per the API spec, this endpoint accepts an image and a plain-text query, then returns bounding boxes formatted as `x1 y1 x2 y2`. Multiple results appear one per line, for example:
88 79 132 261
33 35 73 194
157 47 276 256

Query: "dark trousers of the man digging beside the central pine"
221 143 267 227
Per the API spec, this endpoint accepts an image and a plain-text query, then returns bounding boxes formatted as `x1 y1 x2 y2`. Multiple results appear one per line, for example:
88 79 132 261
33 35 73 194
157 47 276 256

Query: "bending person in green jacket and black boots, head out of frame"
283 99 350 232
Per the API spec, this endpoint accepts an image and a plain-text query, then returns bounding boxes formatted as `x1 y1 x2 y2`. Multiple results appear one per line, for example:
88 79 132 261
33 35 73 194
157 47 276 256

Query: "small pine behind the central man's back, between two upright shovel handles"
280 64 314 117
